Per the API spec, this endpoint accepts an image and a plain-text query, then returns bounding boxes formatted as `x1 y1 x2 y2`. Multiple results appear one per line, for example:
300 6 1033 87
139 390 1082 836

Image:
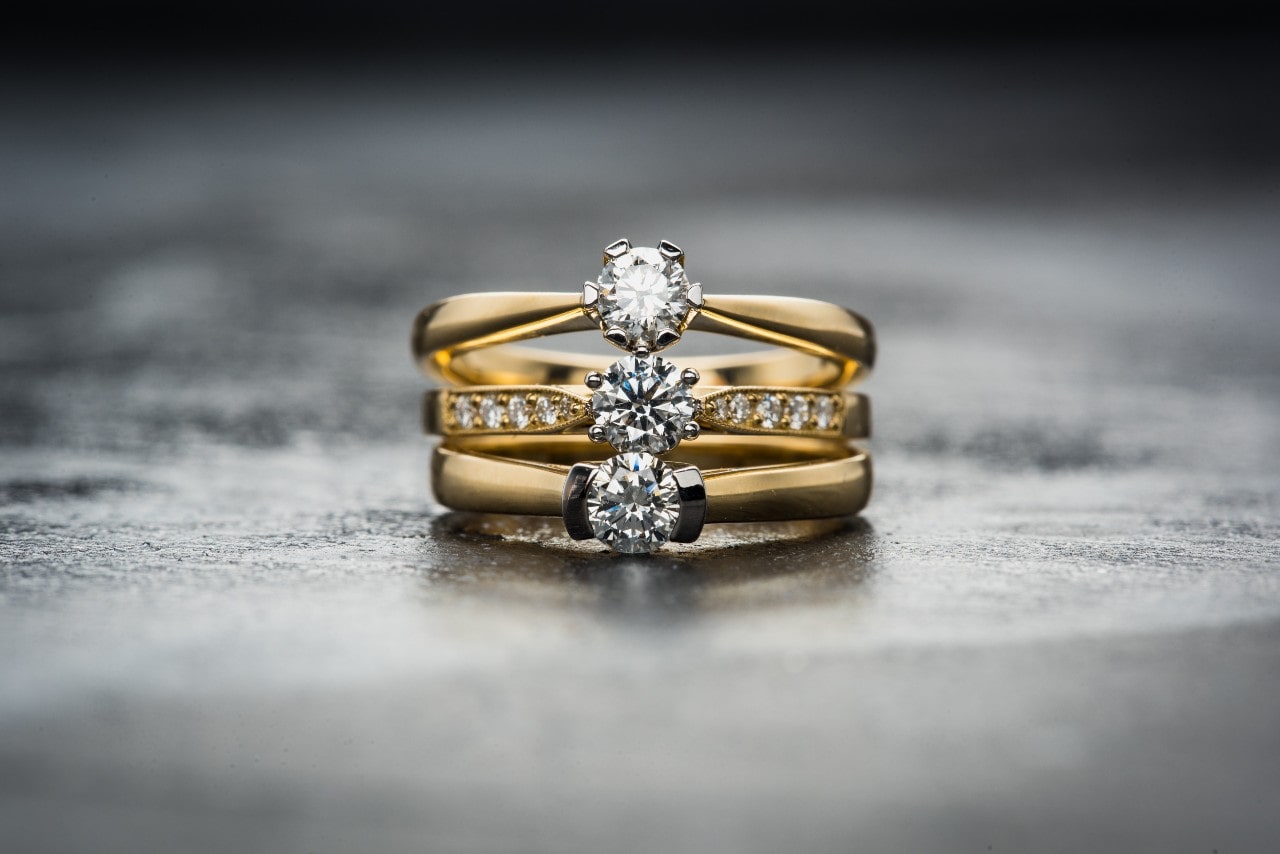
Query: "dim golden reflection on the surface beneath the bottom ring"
431 512 876 620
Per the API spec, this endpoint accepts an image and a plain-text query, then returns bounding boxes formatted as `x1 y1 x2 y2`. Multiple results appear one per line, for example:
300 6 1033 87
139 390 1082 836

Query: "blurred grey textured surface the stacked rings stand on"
0 50 1280 854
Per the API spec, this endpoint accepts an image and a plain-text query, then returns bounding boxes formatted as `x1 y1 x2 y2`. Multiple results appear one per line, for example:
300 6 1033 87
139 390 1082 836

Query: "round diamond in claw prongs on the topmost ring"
598 247 689 350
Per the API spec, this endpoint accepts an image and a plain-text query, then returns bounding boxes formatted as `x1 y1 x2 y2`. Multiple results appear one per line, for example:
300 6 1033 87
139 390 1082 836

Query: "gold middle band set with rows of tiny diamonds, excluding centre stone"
422 385 872 439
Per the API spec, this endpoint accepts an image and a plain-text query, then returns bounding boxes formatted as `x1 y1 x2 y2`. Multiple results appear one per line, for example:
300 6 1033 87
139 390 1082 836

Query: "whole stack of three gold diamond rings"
413 239 876 554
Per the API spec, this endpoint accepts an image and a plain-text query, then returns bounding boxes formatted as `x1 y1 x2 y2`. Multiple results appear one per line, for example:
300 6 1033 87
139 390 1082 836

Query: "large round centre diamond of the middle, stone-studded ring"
591 356 698 453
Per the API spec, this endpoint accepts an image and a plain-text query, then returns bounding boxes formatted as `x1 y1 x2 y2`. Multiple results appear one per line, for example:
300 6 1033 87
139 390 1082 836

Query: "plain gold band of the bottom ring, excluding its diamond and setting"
431 435 872 522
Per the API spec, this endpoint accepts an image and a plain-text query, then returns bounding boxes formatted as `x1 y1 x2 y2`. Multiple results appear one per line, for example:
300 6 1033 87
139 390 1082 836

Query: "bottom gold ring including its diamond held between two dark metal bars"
431 437 872 553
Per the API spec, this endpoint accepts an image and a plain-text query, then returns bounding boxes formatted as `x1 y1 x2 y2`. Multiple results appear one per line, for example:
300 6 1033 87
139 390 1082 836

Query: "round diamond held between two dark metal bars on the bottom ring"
586 453 680 554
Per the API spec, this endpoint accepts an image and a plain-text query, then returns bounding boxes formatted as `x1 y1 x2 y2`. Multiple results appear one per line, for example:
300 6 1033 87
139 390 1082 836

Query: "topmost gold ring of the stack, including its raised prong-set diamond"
412 238 876 388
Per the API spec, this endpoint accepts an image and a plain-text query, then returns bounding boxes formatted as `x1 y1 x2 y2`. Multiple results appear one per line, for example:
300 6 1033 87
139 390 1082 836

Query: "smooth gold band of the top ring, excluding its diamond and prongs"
413 292 876 388
